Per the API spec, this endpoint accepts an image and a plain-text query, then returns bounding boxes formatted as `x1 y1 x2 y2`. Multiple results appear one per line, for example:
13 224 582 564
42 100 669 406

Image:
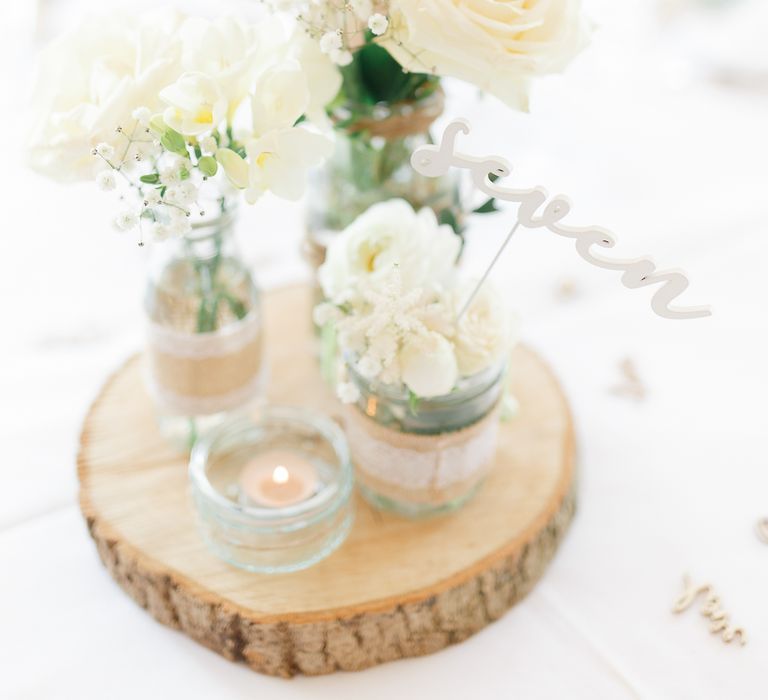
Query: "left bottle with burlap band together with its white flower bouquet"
29 12 335 443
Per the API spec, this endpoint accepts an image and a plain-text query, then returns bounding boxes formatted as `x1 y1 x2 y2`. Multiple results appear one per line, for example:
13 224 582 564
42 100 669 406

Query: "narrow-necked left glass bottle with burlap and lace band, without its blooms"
145 205 264 449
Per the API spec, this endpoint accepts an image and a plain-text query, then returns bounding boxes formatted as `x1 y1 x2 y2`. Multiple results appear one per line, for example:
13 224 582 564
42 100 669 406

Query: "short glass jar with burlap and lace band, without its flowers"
346 362 506 517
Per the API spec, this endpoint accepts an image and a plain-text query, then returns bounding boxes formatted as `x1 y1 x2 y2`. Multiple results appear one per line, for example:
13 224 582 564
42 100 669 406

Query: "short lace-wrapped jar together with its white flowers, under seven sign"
315 200 512 515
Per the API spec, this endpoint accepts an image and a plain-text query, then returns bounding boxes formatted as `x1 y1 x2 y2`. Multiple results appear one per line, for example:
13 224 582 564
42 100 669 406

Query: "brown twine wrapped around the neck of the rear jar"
332 88 445 141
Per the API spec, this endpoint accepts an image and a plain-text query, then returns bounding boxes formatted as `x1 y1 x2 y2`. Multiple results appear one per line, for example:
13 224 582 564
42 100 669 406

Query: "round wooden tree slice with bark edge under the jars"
78 287 574 676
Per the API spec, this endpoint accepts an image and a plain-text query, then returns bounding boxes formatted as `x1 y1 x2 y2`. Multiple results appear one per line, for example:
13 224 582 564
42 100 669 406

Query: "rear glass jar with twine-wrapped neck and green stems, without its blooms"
305 89 463 269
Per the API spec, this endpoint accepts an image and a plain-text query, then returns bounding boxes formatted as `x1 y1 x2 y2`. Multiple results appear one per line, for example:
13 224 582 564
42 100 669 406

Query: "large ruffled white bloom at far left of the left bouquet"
27 11 181 181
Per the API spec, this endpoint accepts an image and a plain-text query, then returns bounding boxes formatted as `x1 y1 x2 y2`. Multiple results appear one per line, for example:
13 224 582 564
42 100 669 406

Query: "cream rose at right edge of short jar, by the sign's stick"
453 284 512 377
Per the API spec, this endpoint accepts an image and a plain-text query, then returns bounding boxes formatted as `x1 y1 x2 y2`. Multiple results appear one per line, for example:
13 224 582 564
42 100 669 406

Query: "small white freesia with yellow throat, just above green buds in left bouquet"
160 73 227 136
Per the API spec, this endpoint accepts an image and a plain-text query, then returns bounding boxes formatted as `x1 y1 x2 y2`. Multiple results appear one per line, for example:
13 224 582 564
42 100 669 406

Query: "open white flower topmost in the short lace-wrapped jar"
319 199 461 299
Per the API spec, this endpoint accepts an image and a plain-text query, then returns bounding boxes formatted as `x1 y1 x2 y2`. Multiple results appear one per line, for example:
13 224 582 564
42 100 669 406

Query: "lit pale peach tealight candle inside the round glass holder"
240 450 318 508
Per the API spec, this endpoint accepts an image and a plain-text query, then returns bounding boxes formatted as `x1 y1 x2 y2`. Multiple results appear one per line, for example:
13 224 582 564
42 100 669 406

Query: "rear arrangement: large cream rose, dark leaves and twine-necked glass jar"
277 0 585 264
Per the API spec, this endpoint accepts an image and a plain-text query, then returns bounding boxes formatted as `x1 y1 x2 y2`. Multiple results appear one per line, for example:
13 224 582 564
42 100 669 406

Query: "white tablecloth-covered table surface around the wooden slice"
0 0 768 700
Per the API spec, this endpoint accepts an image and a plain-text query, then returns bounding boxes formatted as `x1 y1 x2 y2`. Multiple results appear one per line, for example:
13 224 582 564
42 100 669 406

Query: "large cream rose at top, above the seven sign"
381 0 587 109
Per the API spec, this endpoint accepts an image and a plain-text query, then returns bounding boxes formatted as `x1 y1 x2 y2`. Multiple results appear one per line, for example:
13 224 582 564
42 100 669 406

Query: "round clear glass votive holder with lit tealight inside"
189 407 353 573
